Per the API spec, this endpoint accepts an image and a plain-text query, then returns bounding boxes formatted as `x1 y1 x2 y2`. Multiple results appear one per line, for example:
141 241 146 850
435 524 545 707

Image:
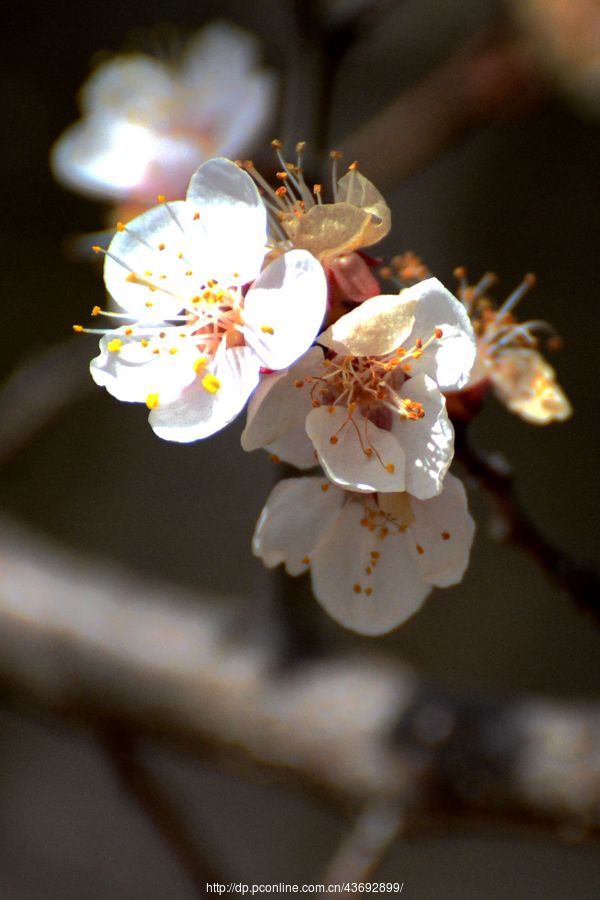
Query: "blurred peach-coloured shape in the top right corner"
511 0 600 115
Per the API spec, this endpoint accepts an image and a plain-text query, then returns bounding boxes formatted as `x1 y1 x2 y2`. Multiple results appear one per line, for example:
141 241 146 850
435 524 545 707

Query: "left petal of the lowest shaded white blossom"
252 478 344 575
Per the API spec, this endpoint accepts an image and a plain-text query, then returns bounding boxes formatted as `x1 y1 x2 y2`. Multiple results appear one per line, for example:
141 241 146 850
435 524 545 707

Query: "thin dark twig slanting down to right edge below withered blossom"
455 422 600 622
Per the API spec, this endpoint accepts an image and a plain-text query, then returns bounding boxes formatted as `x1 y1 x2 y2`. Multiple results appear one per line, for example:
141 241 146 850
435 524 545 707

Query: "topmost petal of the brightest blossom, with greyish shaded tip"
186 158 267 284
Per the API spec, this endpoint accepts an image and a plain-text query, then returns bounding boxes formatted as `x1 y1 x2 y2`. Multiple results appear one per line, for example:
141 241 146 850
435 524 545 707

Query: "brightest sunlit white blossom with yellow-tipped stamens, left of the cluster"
86 159 327 442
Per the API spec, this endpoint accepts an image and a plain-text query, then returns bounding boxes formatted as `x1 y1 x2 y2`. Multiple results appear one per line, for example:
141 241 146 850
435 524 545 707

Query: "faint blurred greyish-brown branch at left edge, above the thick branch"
0 338 93 465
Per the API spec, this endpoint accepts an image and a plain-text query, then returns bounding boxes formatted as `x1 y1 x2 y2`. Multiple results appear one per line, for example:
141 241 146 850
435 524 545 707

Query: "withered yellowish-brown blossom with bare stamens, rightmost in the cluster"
448 269 572 425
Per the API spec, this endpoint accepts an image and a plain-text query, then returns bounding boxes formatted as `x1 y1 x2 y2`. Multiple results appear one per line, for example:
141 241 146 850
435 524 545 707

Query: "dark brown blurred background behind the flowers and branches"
0 0 600 900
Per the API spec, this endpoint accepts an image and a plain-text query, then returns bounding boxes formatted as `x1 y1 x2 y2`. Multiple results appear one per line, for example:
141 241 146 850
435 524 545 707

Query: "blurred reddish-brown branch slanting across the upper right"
340 34 538 189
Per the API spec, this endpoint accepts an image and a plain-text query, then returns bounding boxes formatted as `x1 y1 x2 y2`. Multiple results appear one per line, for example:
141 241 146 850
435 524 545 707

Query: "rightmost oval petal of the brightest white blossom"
244 250 327 370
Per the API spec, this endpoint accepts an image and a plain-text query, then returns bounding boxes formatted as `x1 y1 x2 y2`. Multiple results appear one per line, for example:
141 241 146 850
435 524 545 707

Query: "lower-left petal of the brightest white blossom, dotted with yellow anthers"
90 325 198 403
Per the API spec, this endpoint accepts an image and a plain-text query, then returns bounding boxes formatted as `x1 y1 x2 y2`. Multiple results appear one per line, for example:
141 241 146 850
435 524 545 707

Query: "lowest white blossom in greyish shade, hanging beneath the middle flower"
253 475 475 635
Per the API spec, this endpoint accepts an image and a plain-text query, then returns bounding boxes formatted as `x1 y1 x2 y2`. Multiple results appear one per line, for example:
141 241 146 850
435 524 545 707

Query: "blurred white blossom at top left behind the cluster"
52 22 275 205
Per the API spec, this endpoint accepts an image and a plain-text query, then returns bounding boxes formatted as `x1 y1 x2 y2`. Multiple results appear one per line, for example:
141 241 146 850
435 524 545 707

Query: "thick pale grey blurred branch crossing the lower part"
0 522 600 852
